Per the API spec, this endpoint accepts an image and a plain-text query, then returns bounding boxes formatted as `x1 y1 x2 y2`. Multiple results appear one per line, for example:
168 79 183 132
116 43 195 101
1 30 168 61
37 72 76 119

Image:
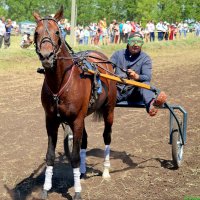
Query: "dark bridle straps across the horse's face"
34 17 62 64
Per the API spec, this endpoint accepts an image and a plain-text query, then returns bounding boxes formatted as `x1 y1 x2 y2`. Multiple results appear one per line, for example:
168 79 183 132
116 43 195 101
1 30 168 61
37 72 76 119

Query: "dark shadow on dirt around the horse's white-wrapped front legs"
5 153 73 200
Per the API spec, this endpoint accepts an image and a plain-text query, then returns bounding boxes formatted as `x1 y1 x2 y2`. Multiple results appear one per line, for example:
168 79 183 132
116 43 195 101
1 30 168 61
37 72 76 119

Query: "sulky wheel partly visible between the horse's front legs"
63 124 73 160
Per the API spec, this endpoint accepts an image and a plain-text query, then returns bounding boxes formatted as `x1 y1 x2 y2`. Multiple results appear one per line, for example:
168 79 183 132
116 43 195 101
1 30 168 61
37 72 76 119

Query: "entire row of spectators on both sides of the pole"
0 17 200 48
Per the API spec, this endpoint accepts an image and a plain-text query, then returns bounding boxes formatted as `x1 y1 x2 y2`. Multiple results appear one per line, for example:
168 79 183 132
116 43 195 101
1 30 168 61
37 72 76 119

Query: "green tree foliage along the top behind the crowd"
0 0 200 25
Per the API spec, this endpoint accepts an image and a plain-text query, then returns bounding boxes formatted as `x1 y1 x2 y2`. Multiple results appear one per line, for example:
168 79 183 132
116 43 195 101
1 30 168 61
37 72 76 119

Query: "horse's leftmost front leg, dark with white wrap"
42 117 59 199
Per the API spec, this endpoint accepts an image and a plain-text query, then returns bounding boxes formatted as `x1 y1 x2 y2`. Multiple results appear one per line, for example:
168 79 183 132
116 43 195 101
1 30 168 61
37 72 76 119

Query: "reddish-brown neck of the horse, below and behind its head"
45 45 73 94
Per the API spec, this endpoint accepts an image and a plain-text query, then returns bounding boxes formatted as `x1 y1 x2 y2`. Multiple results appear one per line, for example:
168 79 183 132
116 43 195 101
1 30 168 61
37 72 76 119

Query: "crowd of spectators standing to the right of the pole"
70 18 200 45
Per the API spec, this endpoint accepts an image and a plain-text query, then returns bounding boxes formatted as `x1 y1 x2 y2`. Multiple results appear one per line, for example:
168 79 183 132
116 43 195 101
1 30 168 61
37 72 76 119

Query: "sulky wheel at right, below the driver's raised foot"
172 122 183 168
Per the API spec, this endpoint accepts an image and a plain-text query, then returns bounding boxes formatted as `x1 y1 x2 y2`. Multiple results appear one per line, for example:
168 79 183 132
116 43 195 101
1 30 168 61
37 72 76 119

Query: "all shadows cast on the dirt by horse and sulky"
5 148 175 200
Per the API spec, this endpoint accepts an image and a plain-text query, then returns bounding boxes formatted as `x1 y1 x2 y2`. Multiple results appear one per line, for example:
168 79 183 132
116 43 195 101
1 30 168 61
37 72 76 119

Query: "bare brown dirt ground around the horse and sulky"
0 49 200 200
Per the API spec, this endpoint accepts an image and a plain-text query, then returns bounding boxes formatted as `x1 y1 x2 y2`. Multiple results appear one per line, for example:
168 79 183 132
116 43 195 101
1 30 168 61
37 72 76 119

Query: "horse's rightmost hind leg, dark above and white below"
102 111 114 180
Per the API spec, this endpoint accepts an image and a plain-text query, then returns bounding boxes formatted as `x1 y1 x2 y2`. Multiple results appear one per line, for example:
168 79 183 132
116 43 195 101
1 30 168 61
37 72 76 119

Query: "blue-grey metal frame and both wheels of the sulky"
62 101 188 169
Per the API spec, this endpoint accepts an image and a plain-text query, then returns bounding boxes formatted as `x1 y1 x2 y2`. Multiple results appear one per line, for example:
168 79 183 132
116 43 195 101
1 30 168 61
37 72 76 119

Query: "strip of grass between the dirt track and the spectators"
0 33 200 72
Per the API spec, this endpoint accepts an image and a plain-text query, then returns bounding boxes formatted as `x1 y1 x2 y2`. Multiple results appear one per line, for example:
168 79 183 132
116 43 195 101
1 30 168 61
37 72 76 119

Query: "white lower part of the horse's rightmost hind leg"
103 145 110 179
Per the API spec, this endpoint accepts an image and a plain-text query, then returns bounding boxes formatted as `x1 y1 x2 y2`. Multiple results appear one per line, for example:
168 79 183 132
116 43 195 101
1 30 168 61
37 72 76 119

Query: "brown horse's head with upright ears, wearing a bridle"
33 7 63 69
